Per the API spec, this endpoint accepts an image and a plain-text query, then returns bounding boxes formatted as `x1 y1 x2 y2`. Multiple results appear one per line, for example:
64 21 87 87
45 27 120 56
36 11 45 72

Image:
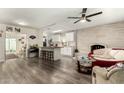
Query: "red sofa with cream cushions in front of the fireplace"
88 48 124 67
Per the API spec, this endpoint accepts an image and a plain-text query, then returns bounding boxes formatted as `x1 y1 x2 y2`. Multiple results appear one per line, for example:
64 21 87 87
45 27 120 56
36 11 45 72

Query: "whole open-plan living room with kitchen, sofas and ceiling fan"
0 8 124 84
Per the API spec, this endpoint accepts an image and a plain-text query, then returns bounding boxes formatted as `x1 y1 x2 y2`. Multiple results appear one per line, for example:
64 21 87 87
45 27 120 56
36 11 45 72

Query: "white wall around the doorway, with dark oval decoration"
0 24 43 60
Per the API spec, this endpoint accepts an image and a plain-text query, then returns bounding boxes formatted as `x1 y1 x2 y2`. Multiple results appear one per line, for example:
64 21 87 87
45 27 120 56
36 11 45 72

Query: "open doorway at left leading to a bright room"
5 32 27 60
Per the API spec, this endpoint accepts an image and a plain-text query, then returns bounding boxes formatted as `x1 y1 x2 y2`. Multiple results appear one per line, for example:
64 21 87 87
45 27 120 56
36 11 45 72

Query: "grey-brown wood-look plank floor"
0 58 91 84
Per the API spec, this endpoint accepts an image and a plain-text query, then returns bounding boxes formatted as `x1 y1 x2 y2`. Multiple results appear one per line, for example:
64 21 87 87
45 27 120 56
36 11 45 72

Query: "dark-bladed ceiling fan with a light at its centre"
68 8 102 24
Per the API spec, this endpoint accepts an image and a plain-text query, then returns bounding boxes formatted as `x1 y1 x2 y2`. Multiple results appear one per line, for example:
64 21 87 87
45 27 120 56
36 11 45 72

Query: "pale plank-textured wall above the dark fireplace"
77 22 124 53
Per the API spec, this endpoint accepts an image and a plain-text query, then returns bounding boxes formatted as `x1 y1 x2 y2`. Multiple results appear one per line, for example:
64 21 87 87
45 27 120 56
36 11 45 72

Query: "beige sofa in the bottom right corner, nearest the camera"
92 62 124 84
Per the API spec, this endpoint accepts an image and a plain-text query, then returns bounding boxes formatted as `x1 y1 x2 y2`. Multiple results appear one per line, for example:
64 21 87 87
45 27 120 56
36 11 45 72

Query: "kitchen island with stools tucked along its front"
39 47 61 61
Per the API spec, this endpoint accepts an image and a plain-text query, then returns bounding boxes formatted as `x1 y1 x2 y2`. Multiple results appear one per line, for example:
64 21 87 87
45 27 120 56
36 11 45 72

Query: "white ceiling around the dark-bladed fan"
0 8 124 32
